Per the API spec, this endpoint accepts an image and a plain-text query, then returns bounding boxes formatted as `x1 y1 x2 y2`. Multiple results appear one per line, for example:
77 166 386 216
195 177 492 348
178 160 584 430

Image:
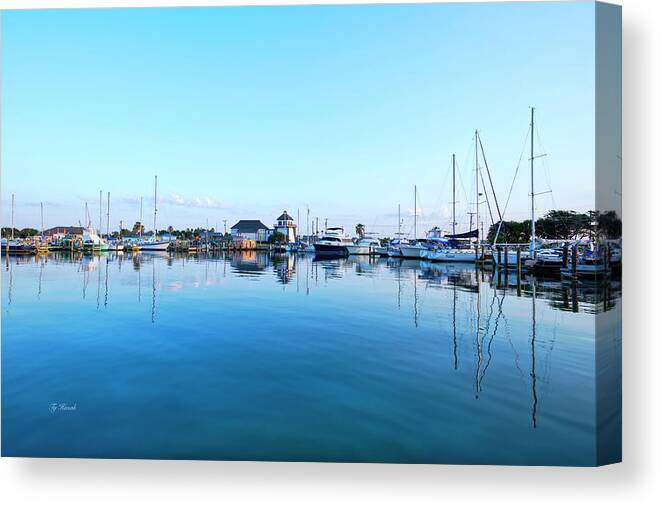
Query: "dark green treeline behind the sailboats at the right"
487 210 622 243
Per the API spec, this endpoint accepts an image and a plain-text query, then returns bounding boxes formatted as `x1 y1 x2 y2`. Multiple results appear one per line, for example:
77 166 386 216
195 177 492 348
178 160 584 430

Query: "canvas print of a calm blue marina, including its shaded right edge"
1 2 623 466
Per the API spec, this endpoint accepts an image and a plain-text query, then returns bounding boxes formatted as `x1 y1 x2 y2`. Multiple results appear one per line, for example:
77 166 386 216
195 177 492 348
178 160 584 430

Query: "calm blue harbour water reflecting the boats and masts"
2 253 620 465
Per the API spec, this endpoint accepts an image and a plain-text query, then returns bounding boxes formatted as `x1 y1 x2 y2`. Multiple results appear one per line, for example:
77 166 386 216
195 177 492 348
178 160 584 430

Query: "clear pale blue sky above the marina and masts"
2 2 594 235
